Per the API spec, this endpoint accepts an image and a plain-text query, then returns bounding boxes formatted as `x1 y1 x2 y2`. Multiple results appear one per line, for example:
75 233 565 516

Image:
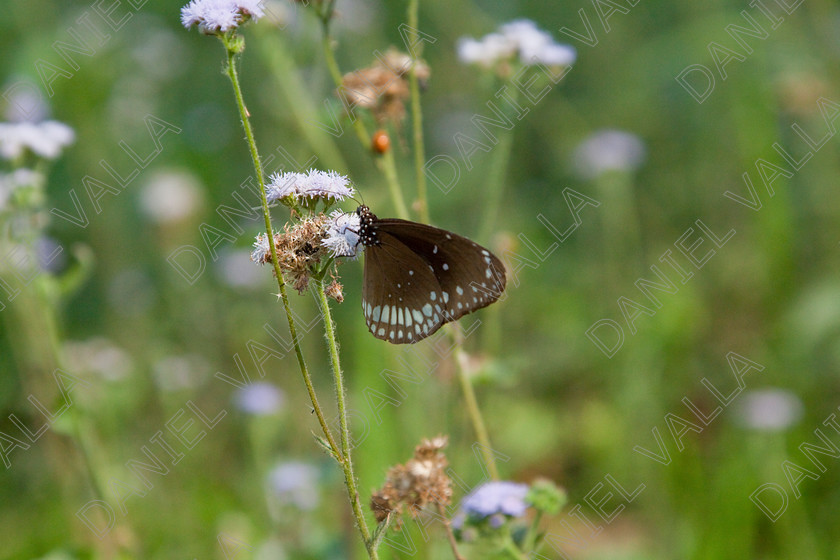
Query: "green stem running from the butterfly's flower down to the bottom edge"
315 282 378 560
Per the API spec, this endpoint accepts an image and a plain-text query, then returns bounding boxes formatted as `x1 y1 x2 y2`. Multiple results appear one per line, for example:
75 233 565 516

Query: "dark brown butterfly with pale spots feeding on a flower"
359 207 505 344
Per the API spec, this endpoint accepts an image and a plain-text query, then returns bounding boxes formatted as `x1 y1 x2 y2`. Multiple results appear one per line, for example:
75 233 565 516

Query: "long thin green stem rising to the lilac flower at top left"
223 40 343 460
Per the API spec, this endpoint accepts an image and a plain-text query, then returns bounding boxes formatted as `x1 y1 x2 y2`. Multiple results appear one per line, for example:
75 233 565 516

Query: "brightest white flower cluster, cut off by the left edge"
0 121 76 159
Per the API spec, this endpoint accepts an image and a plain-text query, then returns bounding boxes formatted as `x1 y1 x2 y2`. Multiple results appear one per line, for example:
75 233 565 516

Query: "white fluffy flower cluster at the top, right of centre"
457 19 577 68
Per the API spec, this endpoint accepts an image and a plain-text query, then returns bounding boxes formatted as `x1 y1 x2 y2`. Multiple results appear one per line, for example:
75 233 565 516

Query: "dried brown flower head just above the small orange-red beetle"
337 49 429 123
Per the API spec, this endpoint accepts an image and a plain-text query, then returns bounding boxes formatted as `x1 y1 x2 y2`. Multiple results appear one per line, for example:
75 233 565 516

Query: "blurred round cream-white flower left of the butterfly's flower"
140 171 203 224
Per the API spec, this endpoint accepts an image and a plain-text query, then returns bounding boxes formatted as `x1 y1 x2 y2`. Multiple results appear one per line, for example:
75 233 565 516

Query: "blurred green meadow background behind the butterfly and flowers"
0 0 840 559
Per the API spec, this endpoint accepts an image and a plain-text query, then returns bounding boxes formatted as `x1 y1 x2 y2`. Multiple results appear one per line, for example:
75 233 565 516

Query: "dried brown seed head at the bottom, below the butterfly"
370 436 452 527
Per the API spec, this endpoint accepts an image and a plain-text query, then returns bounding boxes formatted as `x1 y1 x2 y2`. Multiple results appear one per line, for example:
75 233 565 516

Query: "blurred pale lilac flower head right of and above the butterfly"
573 130 645 179
